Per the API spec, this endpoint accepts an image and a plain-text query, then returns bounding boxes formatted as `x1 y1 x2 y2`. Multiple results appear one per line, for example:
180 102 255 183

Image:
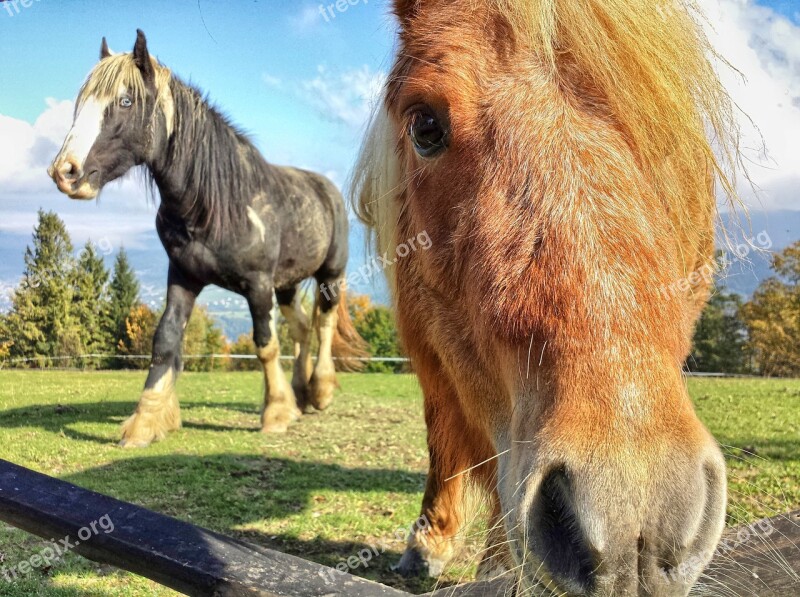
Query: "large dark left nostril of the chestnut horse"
528 468 596 594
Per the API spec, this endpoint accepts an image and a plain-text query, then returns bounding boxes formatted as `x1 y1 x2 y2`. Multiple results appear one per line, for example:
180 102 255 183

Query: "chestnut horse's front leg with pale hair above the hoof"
395 354 494 576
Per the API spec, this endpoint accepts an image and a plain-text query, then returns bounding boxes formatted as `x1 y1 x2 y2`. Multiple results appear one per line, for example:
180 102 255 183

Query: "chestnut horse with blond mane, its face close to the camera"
354 0 735 596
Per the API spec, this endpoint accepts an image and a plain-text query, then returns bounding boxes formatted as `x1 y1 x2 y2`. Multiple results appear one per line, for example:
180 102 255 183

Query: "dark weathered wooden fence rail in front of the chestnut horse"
0 460 800 597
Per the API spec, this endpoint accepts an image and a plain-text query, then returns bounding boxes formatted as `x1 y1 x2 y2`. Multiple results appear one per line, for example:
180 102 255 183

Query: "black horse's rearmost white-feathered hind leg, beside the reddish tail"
309 278 340 410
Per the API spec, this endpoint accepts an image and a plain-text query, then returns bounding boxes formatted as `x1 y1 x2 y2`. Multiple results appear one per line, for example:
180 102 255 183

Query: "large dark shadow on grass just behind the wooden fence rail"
62 454 436 593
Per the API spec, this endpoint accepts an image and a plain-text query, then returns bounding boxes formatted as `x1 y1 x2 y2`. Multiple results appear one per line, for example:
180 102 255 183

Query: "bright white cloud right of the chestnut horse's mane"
701 0 800 209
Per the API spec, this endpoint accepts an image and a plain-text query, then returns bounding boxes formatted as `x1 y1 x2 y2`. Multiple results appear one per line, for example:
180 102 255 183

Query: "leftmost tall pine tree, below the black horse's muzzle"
6 210 81 364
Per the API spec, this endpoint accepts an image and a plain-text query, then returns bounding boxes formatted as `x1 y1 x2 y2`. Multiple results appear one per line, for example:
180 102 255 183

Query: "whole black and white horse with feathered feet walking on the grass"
49 31 363 447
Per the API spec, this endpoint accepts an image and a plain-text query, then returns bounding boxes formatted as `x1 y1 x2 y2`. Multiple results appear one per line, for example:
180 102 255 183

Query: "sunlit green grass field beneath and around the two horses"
0 371 800 597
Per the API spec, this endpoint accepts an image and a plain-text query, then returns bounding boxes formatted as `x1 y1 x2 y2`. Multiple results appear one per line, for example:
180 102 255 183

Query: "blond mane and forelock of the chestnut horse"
353 0 738 288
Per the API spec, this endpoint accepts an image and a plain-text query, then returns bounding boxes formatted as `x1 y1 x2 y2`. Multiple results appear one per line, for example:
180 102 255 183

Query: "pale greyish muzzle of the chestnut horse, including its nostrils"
510 428 726 597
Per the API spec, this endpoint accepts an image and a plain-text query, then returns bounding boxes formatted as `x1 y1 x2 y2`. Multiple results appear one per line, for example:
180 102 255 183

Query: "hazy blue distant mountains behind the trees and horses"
0 210 800 339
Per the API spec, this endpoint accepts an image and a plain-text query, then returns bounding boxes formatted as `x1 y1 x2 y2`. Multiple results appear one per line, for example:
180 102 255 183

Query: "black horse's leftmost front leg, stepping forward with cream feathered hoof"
120 267 201 448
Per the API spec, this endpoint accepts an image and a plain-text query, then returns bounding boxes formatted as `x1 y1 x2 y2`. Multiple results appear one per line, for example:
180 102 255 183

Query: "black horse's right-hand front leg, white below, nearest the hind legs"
247 285 302 433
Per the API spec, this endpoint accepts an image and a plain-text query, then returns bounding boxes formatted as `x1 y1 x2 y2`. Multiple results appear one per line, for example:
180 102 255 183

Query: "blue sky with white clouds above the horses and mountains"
0 0 800 312
